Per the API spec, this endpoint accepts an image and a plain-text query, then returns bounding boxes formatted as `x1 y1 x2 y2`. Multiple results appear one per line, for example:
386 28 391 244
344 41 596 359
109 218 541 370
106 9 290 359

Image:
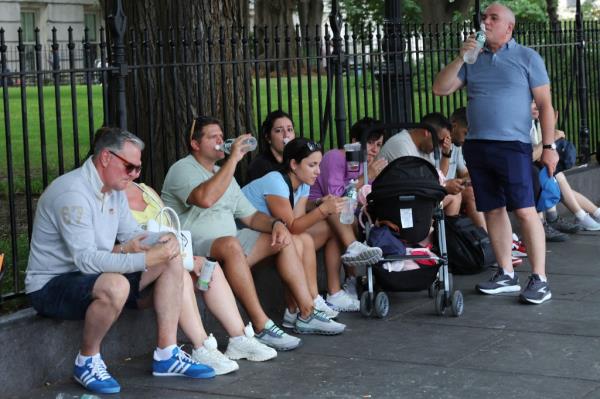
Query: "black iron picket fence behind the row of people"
0 10 600 301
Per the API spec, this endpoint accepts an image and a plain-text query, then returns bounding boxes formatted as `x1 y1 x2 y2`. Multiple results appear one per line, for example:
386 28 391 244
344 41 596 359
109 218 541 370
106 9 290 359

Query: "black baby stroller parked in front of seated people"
360 124 464 318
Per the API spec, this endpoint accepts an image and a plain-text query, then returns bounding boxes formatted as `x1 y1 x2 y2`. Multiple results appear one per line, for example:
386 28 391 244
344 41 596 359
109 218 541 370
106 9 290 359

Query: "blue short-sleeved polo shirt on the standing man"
458 39 550 143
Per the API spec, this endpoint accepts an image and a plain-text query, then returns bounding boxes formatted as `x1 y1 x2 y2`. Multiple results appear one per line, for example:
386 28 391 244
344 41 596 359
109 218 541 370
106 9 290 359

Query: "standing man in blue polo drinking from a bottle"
433 3 558 304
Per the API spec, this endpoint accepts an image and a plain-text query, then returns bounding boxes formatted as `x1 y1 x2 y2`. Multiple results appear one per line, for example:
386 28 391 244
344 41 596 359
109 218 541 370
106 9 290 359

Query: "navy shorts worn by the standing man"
463 140 534 212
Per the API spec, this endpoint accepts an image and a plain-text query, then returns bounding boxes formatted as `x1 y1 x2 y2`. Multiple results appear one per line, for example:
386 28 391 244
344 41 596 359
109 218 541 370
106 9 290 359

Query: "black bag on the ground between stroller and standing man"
444 216 496 274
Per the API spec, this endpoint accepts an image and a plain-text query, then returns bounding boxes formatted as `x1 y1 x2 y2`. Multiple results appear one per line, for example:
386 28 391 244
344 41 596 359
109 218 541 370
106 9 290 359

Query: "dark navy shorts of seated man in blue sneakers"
29 272 142 320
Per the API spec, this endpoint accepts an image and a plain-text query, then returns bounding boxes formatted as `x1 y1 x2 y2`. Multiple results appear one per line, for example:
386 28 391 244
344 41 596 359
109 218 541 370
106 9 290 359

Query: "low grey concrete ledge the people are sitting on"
0 259 292 397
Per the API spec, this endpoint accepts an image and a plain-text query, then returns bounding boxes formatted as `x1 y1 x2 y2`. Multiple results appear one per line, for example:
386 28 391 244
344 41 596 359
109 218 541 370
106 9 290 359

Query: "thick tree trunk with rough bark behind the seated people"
106 0 247 189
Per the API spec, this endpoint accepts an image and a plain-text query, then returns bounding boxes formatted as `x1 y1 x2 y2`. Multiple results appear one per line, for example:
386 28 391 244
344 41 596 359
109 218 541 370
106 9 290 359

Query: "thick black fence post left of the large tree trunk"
108 0 128 129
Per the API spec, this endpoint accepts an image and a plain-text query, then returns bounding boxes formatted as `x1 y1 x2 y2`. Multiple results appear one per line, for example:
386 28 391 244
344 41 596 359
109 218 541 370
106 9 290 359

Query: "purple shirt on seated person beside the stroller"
308 150 362 200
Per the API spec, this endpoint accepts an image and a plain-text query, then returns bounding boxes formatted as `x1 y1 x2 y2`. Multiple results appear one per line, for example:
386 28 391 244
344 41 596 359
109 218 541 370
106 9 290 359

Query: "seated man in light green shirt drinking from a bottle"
162 117 345 350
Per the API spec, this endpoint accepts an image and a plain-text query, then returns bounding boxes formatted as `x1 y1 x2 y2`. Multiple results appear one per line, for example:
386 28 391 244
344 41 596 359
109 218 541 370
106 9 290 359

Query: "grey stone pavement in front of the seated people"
17 228 600 399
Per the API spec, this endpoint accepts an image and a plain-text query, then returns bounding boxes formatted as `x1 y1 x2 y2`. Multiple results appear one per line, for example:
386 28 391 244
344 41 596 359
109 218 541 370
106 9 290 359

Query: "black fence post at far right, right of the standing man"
575 0 590 163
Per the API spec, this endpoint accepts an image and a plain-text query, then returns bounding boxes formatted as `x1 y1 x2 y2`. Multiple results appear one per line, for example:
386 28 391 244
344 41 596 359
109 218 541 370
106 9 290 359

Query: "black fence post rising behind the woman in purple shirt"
329 0 346 148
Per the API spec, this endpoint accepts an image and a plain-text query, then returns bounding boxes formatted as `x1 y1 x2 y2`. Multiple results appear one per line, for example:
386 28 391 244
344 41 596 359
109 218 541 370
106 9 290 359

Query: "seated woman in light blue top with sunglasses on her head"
242 138 381 320
